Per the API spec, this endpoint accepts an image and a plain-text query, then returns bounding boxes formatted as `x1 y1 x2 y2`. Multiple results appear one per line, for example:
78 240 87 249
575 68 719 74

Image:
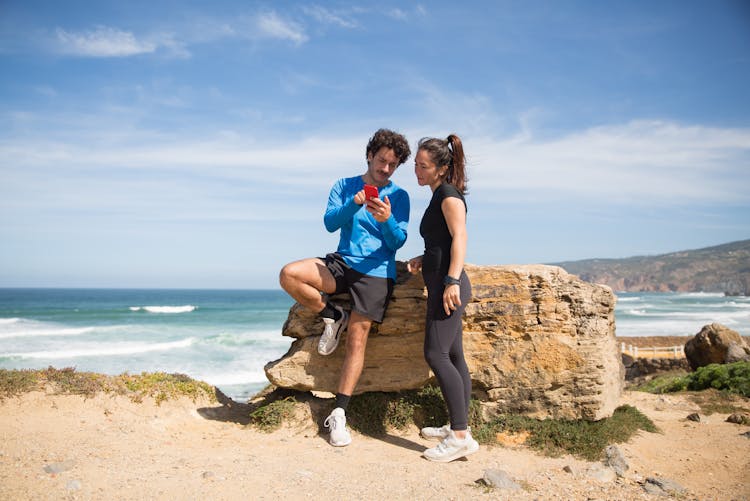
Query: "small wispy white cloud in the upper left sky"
56 26 157 57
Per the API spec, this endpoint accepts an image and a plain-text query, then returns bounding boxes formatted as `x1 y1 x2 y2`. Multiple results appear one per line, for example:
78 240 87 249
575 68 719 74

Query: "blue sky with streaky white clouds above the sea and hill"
0 0 750 288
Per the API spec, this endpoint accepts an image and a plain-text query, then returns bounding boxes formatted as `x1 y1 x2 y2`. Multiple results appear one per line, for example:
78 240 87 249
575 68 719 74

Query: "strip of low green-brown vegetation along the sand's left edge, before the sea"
0 367 216 403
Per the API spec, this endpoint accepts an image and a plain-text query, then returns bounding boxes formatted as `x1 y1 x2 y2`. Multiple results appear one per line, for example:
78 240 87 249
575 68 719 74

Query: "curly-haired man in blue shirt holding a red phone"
279 129 411 447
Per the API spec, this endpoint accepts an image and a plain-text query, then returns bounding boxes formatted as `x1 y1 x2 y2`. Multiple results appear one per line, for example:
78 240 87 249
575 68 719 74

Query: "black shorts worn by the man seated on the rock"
320 252 393 323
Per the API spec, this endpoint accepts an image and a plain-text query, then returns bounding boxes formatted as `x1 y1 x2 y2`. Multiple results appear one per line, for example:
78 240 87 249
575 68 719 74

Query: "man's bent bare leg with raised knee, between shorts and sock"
279 258 336 312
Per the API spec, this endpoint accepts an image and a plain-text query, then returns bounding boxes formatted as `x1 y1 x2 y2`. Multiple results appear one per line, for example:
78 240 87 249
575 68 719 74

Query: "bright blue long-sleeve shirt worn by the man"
323 176 409 280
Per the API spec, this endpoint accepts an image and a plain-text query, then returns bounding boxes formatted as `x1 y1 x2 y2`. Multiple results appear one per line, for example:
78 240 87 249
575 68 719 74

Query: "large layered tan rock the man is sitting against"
265 263 624 420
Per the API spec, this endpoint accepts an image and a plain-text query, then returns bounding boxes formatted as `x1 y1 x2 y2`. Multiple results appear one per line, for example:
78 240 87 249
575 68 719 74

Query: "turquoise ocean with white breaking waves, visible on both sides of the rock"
0 289 750 402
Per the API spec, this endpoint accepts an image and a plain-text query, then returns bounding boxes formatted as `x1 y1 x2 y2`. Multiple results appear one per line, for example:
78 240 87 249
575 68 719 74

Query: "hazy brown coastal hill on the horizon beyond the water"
552 240 750 296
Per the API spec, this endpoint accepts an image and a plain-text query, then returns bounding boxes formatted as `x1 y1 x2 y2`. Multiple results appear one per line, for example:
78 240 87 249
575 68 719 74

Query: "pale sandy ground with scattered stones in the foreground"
0 392 750 500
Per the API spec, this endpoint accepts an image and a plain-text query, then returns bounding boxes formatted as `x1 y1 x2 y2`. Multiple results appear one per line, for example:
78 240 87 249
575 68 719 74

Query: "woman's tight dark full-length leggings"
423 272 471 431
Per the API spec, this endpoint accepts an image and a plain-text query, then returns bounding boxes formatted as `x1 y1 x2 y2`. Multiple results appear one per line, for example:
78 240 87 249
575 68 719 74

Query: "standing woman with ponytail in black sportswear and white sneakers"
409 134 479 462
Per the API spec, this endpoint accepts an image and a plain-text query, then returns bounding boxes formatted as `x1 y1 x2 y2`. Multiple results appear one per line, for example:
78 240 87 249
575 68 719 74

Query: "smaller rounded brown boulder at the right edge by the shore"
685 323 750 370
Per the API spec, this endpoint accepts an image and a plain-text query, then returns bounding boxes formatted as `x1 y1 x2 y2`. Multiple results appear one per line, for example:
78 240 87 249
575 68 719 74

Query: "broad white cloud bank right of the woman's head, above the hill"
467 120 750 206
